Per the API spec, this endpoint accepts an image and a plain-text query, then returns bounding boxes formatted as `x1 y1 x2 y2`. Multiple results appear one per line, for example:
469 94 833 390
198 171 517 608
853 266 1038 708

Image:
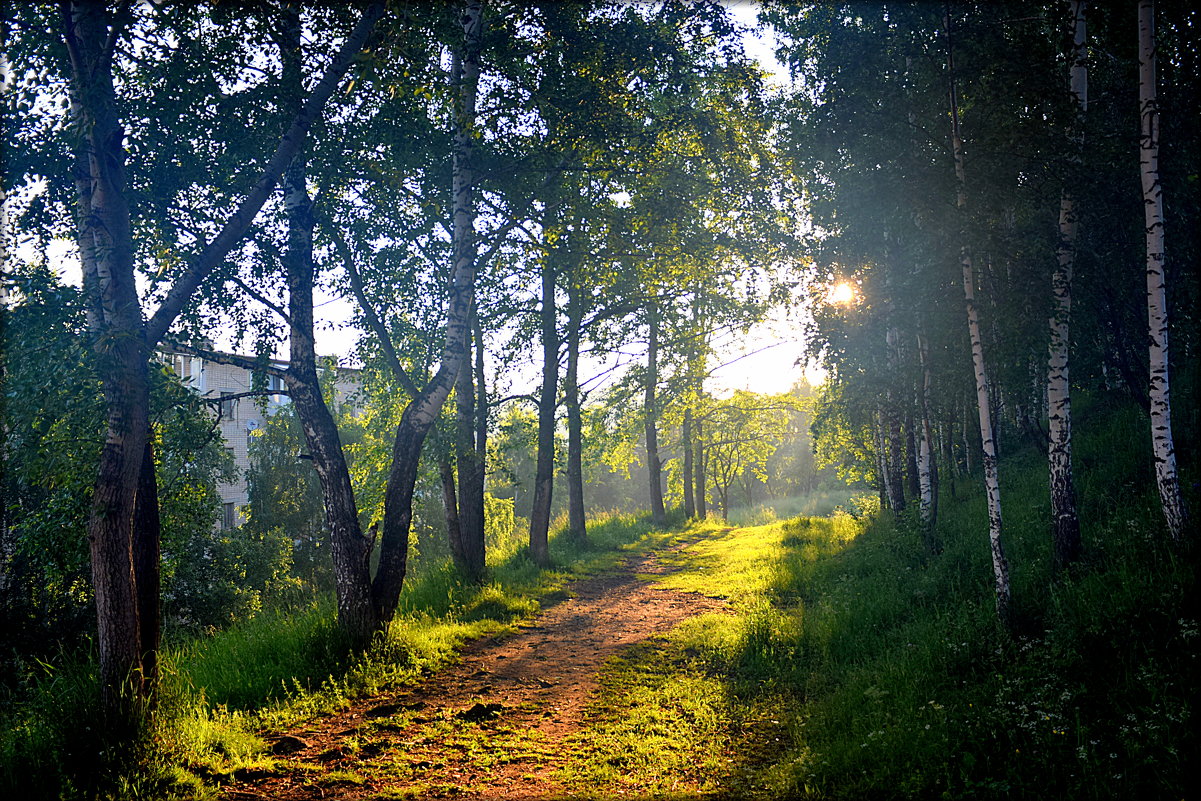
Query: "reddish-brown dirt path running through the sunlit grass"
222 545 724 801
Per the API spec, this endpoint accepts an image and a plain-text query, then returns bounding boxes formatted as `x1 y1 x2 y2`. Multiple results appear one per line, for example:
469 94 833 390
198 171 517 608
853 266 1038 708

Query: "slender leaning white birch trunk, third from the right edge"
945 5 1012 624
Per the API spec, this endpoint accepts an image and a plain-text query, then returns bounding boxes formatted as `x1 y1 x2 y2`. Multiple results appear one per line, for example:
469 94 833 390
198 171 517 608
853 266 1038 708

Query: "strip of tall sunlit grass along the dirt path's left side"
0 515 652 801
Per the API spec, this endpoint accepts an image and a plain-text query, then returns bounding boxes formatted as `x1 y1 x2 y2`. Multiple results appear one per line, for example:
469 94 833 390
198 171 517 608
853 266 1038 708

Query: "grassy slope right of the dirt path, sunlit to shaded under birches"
567 398 1199 799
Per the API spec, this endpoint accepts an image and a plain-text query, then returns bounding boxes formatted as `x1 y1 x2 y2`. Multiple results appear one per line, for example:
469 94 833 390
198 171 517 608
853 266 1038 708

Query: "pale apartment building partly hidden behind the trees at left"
160 349 350 528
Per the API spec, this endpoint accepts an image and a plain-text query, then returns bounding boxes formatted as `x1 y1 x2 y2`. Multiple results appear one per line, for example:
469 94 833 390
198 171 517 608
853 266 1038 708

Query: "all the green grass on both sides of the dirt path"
7 402 1201 799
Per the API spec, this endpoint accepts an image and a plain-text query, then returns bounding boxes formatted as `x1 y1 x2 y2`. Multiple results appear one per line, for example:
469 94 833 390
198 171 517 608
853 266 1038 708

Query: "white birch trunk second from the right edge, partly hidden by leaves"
1046 0 1088 569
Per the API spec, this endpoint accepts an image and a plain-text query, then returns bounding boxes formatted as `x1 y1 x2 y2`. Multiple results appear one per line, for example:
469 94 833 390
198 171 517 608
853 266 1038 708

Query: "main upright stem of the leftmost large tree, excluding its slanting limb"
62 2 157 715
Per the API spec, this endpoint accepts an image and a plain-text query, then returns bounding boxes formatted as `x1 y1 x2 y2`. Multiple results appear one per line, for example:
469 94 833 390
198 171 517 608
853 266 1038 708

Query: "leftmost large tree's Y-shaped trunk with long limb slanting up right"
54 2 383 719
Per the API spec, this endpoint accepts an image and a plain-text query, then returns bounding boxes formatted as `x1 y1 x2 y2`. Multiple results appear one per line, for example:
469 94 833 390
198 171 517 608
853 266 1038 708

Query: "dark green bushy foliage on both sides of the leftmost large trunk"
0 265 246 658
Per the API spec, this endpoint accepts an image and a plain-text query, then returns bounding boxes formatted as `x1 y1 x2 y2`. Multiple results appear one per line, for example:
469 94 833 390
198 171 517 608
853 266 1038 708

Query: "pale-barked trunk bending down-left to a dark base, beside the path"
371 0 483 627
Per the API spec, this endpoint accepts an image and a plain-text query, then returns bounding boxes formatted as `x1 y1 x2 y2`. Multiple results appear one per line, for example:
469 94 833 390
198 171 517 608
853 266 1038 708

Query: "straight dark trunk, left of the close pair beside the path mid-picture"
530 241 558 567
